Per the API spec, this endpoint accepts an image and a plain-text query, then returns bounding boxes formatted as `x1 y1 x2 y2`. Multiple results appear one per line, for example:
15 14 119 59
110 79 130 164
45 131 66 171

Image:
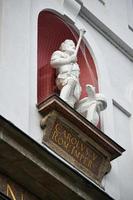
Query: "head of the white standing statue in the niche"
59 39 75 53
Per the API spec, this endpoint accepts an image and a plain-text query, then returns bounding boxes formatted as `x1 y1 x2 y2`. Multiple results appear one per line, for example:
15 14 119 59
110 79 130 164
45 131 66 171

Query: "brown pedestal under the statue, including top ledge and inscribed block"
38 95 124 186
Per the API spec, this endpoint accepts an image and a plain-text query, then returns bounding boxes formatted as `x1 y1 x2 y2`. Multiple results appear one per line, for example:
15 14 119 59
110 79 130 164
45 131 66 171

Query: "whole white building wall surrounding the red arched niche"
0 0 133 200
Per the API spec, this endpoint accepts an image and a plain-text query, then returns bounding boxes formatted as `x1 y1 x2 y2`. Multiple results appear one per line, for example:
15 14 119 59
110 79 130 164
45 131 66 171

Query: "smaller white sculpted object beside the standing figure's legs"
76 84 107 126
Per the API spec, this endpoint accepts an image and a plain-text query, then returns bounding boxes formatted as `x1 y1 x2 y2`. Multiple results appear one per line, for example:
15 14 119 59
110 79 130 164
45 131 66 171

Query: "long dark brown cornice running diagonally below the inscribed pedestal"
0 105 123 200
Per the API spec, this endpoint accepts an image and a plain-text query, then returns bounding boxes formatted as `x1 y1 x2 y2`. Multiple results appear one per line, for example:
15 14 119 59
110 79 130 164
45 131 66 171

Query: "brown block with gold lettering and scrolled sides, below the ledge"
42 111 110 184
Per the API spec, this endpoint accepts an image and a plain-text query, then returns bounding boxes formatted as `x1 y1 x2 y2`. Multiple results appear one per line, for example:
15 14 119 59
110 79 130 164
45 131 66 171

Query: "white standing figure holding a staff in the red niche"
50 39 81 107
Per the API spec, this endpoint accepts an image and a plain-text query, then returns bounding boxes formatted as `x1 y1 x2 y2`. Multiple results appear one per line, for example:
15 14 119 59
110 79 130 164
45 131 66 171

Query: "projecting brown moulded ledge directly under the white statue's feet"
38 95 125 160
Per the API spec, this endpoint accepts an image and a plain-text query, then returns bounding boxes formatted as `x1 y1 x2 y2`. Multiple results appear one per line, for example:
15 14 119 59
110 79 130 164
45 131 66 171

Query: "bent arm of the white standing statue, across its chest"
50 51 77 68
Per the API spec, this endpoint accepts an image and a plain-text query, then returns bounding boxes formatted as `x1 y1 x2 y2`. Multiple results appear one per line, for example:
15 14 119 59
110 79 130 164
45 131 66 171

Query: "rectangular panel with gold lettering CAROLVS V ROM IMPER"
49 120 103 175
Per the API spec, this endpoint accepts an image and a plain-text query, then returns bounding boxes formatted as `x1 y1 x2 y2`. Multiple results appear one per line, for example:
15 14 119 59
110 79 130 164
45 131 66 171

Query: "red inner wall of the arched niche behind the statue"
37 11 98 104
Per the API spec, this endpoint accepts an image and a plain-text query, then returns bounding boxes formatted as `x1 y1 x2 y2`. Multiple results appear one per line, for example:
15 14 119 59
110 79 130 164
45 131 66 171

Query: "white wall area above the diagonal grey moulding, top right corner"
83 0 133 47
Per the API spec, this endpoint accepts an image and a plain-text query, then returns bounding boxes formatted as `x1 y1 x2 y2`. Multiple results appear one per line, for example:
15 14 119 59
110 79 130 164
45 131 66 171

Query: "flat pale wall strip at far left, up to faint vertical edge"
0 0 30 131
